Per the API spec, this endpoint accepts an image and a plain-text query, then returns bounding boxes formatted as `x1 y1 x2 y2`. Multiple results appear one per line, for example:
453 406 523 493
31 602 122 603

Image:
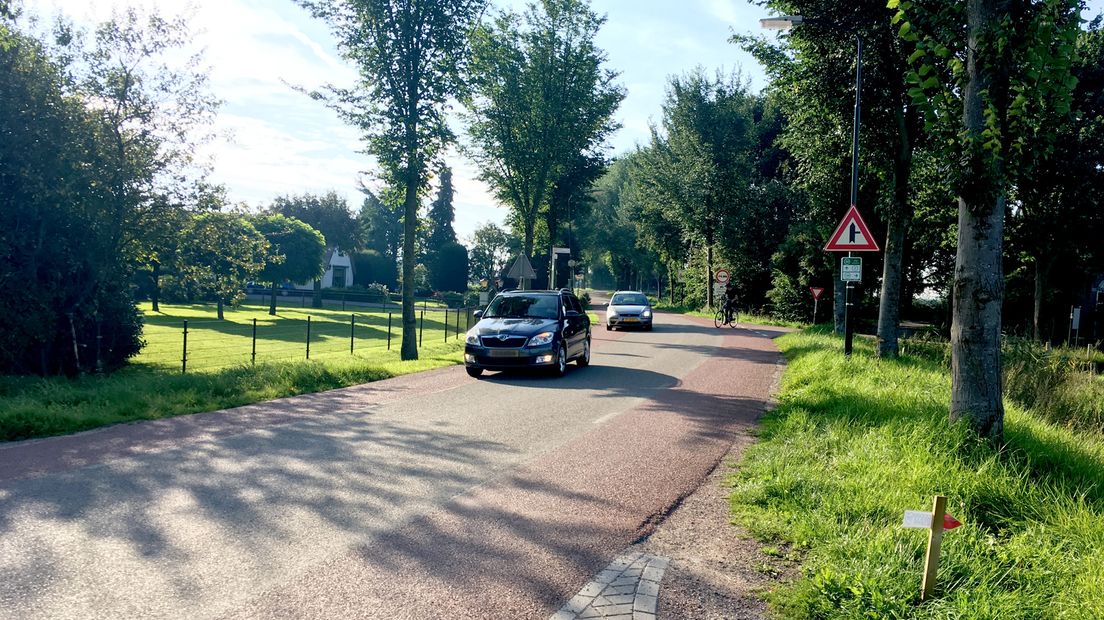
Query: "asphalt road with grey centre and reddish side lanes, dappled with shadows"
0 316 779 619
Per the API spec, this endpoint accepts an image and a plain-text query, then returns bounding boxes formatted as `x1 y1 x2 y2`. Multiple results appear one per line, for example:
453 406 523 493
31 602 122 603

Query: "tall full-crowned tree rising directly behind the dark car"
467 0 625 256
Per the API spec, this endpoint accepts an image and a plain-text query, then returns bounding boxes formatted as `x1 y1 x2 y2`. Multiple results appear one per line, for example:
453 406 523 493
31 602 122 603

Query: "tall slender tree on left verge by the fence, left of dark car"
299 0 486 360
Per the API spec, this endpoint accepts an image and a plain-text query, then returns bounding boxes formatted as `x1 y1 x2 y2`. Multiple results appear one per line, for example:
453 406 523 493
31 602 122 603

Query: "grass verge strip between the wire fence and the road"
0 340 464 441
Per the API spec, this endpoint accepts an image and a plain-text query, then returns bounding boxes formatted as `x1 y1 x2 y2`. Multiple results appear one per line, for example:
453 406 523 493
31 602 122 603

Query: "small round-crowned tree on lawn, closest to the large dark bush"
180 212 269 321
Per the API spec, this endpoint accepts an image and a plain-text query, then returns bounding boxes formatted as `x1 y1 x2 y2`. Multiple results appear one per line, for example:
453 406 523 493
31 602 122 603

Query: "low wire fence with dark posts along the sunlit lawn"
137 308 474 373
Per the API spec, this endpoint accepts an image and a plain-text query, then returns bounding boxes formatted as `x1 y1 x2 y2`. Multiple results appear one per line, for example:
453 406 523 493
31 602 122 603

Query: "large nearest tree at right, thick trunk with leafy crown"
890 0 1080 441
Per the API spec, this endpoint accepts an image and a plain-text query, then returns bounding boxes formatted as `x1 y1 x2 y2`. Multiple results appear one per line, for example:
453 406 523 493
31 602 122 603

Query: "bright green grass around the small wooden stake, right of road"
732 329 1104 619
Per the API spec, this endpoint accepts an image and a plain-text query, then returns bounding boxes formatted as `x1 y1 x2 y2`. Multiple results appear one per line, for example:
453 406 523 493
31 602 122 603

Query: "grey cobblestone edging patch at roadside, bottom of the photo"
550 552 670 620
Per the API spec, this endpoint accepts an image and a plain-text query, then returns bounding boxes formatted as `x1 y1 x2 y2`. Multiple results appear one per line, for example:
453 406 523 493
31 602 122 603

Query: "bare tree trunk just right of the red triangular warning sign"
878 107 912 359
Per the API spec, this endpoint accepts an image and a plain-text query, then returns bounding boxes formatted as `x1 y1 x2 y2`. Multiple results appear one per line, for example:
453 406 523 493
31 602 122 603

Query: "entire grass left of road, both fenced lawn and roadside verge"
0 304 466 441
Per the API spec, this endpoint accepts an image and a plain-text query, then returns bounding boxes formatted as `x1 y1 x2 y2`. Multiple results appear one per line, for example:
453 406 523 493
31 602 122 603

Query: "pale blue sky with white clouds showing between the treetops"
38 0 1104 238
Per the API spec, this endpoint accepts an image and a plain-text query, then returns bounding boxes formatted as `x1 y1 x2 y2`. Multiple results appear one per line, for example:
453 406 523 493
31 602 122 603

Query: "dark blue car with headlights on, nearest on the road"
464 290 591 377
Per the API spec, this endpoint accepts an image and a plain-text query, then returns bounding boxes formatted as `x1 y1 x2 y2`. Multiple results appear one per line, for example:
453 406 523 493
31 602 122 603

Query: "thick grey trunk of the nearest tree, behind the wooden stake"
951 0 1007 442
